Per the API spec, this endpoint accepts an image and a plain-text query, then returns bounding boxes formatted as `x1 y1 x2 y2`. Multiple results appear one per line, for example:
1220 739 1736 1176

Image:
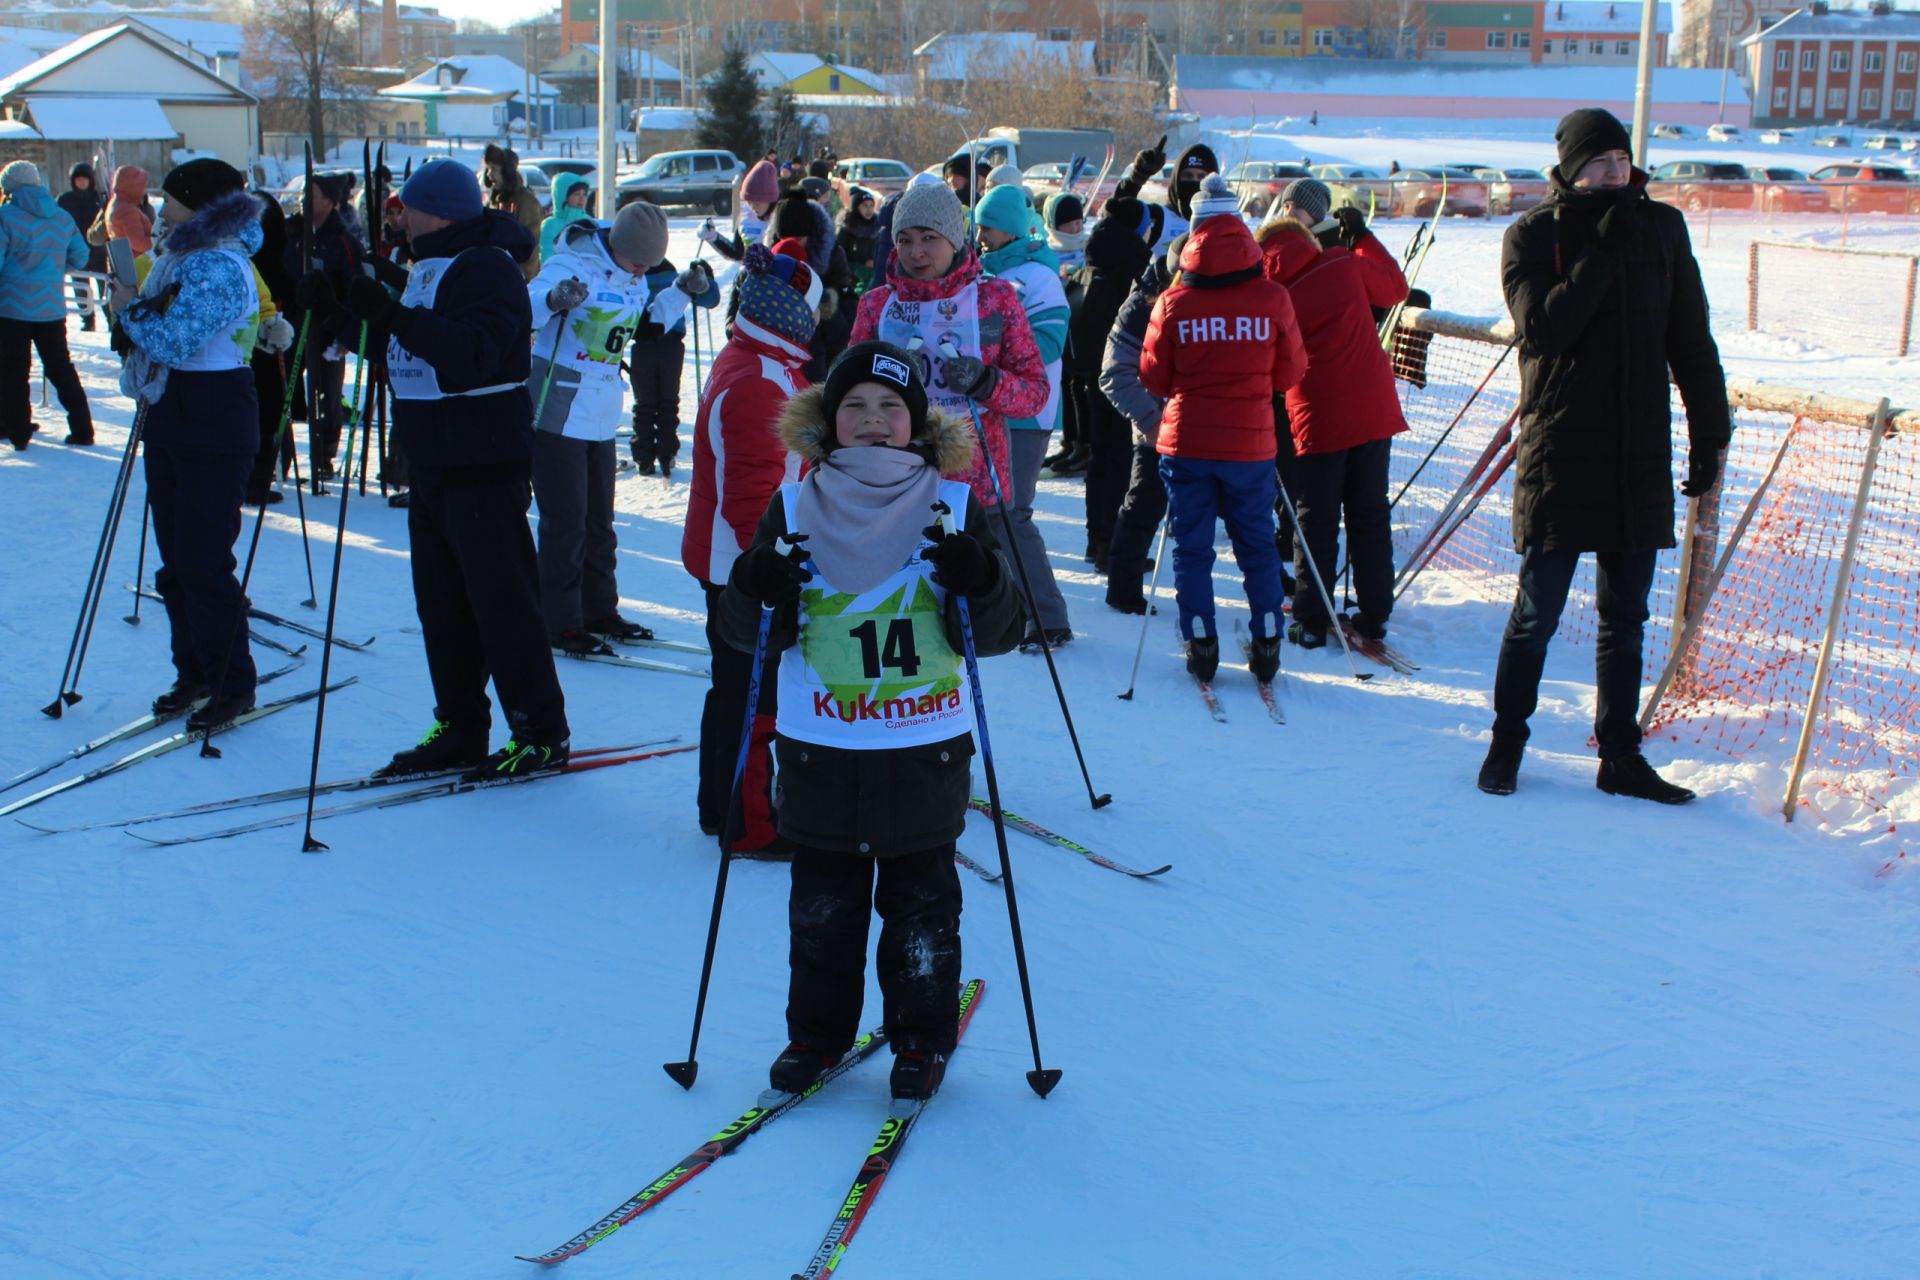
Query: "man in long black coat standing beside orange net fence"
1478 107 1732 804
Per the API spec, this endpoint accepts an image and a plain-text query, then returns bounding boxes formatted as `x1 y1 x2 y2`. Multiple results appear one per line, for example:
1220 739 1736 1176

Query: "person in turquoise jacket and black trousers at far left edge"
0 159 94 449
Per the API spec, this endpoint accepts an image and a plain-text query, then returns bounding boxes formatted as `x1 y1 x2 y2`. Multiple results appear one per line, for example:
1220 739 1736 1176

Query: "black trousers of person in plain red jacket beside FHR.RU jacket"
1288 439 1394 629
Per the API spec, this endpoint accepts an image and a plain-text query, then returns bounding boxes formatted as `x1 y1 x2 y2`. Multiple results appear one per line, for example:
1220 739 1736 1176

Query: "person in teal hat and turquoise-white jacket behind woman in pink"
973 186 1073 652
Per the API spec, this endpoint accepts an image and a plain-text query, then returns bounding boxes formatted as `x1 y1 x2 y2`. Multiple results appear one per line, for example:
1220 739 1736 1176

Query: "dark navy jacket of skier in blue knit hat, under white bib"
388 209 534 484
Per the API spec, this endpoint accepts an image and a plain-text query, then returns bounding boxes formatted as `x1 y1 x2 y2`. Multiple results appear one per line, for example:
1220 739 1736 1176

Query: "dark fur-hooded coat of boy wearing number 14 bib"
716 388 1025 858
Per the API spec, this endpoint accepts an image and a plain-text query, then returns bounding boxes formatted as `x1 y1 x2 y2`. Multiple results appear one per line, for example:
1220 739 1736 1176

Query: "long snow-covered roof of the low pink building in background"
1173 54 1745 104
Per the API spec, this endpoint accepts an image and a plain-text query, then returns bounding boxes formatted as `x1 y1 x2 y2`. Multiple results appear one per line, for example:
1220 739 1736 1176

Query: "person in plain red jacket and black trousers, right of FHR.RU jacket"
1258 178 1407 649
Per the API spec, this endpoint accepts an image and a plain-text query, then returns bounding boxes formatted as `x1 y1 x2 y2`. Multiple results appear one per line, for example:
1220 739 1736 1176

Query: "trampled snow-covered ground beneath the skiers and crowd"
0 214 1920 1280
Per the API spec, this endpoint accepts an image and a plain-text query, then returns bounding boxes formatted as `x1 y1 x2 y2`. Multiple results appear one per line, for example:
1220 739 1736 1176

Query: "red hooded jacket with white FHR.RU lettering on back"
1140 215 1308 462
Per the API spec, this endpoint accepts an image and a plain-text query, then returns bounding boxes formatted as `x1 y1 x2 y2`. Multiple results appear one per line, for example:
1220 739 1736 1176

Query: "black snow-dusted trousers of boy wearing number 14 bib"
787 844 960 1054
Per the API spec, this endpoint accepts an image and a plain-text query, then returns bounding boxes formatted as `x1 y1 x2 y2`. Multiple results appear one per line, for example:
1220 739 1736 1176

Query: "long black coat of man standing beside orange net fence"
1500 169 1732 551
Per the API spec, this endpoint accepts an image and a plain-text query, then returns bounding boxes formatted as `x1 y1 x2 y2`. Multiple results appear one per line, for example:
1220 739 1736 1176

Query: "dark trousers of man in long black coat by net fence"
1494 547 1657 756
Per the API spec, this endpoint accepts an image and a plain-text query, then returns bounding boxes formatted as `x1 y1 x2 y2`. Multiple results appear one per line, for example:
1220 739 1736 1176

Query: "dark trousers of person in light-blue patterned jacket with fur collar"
144 437 255 697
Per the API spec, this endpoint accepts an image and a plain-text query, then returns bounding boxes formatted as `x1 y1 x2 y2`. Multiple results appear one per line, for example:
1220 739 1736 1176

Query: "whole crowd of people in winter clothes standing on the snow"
11 102 1728 1096
